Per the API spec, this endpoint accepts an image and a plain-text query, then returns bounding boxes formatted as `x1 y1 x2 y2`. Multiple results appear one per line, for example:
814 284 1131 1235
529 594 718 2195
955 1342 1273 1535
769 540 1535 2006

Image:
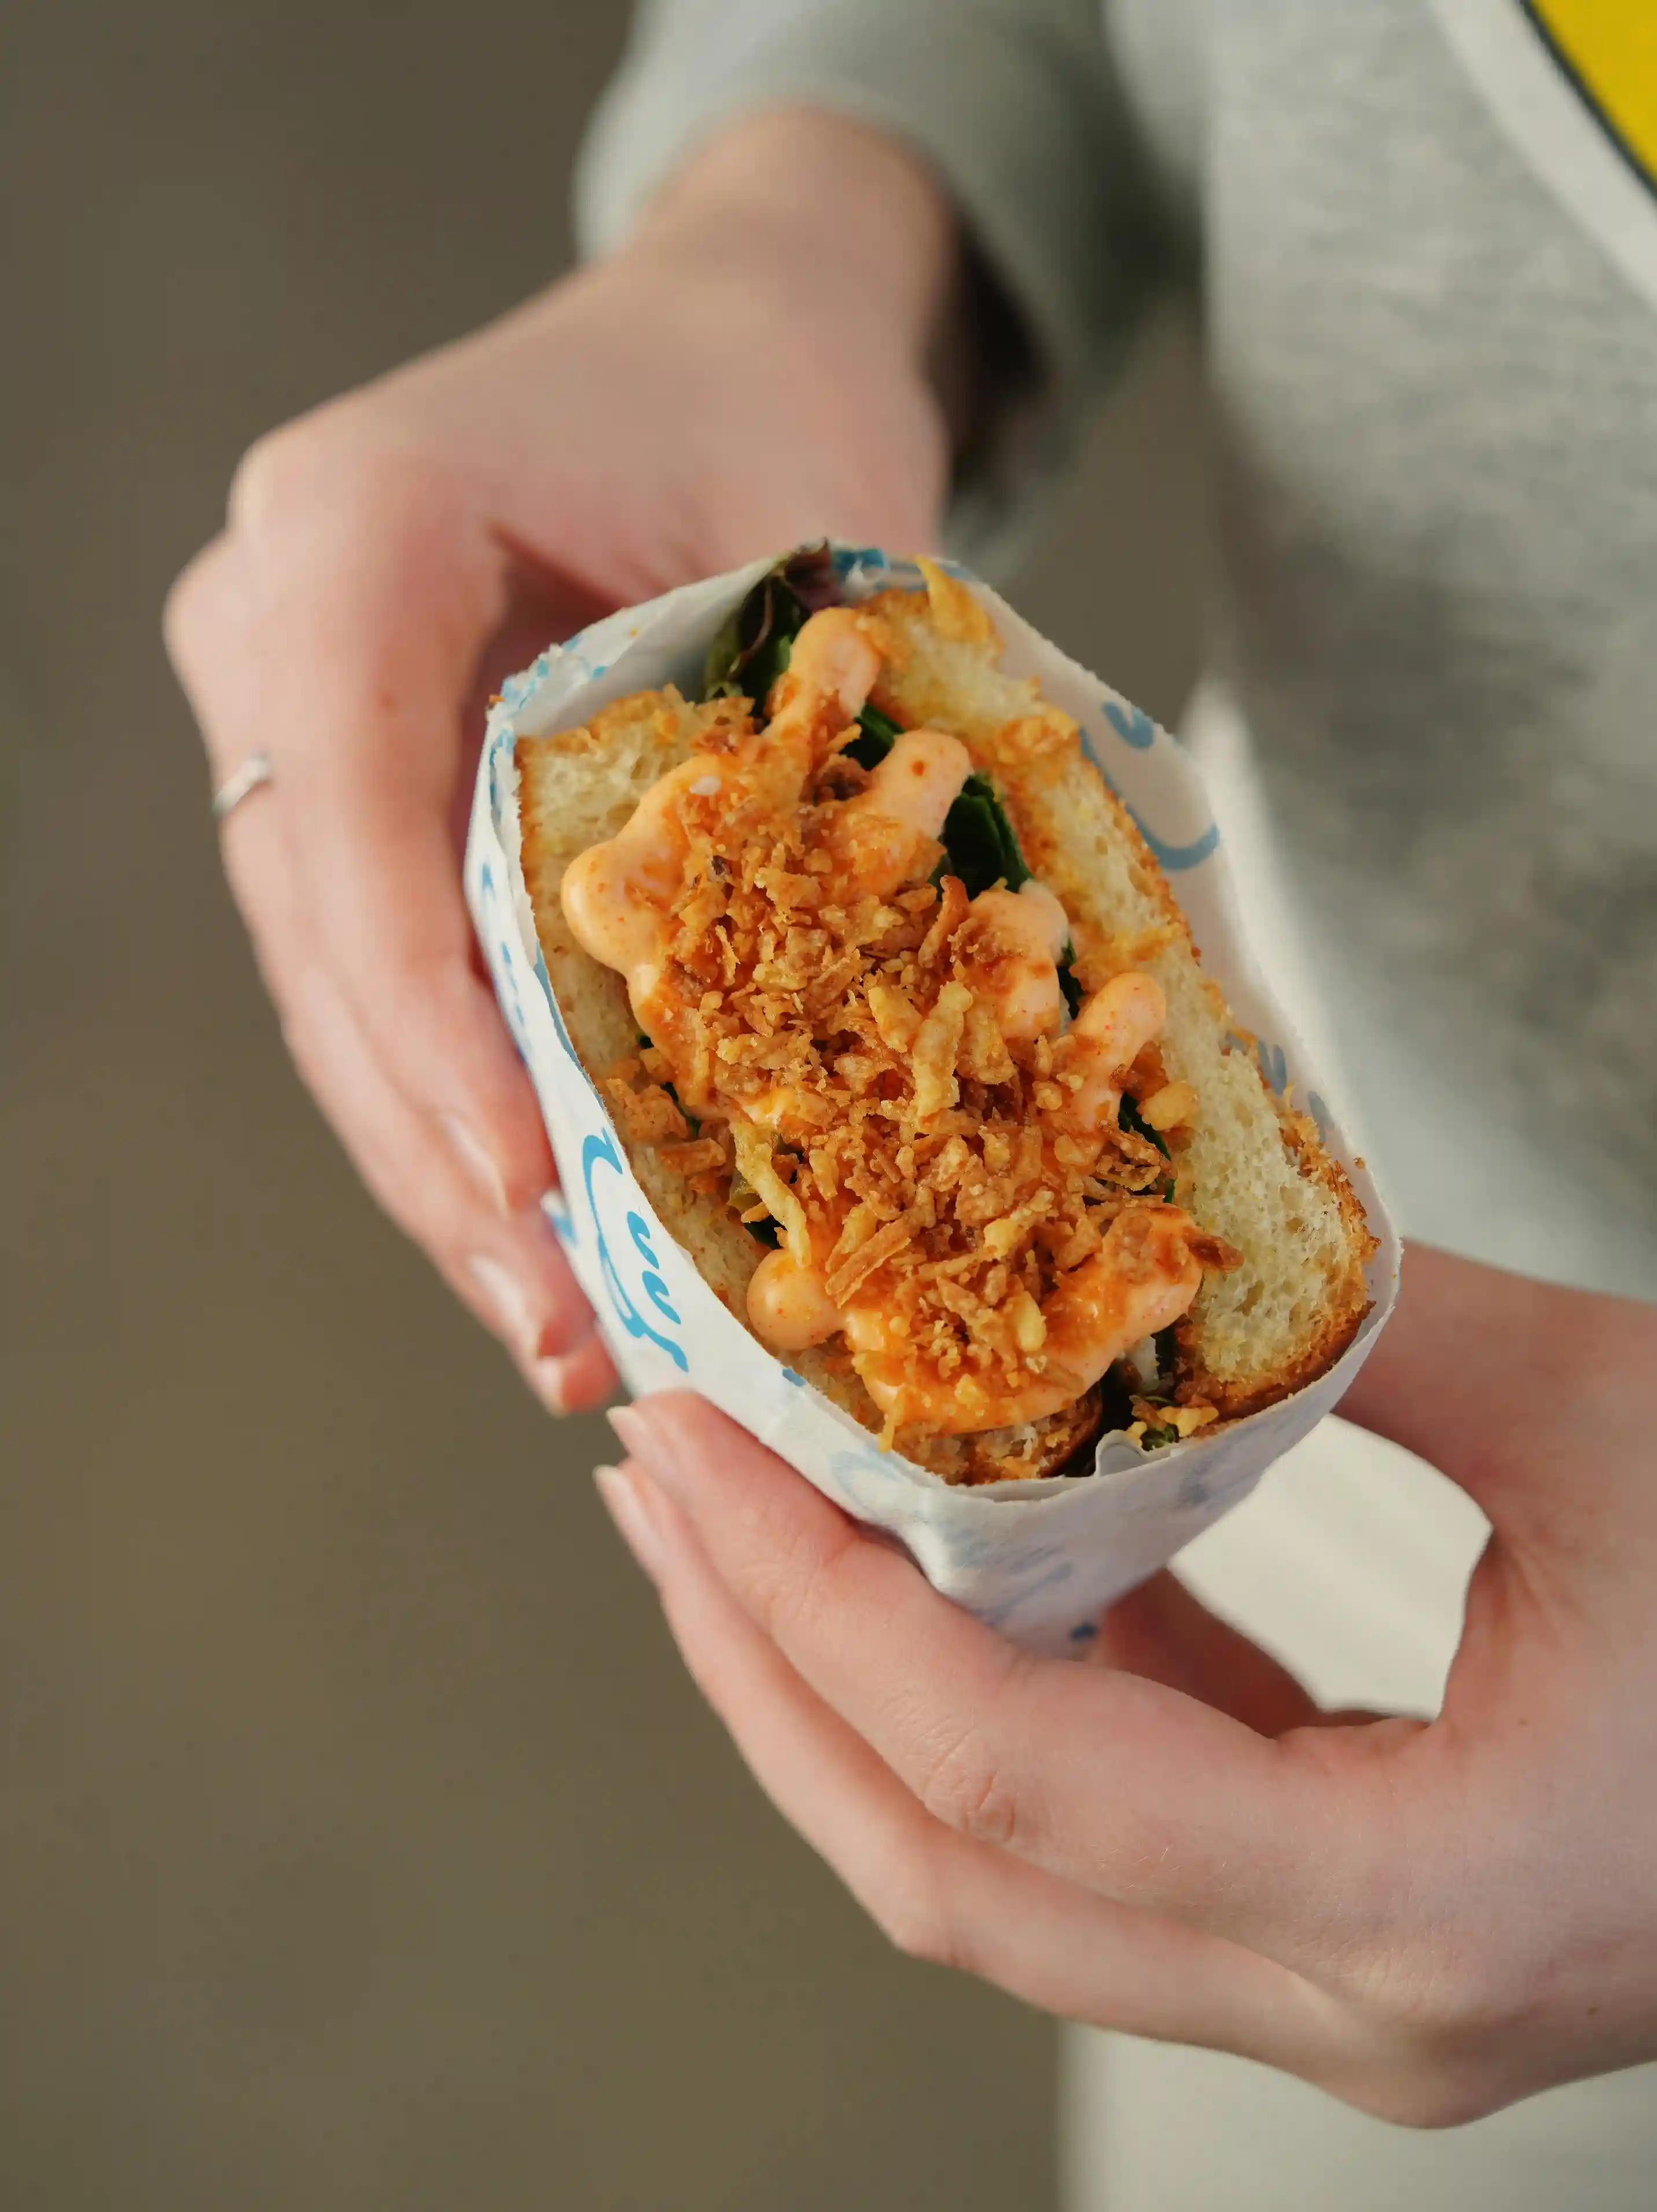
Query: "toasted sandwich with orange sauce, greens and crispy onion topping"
516 549 1374 1484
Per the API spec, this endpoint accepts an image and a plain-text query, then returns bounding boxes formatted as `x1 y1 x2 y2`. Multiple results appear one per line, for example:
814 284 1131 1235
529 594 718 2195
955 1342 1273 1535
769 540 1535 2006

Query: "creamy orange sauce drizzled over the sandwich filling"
562 608 1202 1436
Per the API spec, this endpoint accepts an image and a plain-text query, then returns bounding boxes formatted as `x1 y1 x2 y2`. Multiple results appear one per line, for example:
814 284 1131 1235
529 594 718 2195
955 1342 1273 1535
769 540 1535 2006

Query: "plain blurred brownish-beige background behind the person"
0 0 1203 2212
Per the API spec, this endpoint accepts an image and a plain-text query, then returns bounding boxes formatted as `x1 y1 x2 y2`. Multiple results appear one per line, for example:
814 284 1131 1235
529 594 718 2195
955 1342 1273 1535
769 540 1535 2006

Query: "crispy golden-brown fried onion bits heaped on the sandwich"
575 667 1237 1449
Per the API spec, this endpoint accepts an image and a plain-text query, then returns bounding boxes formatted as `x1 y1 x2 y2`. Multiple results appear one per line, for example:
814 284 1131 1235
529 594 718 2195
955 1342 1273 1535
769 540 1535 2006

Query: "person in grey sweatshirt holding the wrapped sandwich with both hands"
168 0 1657 2212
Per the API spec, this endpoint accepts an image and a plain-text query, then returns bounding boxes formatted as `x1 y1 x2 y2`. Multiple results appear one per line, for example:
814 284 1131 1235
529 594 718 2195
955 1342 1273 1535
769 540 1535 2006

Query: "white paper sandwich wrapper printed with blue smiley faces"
465 546 1398 1652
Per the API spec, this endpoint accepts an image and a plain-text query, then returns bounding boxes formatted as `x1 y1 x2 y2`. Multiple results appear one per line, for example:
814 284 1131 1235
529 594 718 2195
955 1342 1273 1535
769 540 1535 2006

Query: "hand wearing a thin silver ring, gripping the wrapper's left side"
166 115 953 1409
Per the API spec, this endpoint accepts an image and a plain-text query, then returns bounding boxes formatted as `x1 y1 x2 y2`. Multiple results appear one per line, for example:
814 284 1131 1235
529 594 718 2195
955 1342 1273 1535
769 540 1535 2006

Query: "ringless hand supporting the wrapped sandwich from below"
602 1248 1657 2126
